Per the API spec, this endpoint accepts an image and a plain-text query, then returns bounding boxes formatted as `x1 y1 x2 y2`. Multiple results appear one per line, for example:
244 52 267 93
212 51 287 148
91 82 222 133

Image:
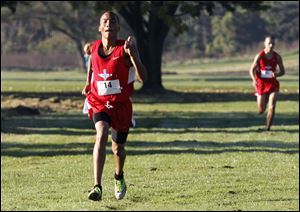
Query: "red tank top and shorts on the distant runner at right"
255 50 279 95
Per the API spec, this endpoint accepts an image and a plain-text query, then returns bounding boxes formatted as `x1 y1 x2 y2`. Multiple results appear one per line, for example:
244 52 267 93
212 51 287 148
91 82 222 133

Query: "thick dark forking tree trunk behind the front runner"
119 1 178 93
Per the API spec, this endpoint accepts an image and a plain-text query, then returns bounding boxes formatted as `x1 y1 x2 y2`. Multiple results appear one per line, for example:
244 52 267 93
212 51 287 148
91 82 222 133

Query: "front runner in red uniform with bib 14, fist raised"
82 11 147 200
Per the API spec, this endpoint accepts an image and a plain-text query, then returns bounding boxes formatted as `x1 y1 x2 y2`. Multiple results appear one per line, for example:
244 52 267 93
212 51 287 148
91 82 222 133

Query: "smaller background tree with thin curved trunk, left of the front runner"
1 1 99 71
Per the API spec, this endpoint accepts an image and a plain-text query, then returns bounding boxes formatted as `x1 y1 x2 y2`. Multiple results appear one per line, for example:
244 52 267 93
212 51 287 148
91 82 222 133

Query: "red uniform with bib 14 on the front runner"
84 40 135 132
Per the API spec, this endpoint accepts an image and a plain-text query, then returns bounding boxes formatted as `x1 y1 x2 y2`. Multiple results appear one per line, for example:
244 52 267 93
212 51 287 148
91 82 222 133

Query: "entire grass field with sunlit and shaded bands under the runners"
1 54 299 211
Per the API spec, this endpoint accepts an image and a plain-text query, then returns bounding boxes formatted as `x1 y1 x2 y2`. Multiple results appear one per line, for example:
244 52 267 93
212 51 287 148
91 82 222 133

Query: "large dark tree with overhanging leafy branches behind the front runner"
90 1 263 93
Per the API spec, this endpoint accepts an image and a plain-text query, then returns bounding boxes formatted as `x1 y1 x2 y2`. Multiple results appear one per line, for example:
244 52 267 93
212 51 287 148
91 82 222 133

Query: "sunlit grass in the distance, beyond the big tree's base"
1 52 299 94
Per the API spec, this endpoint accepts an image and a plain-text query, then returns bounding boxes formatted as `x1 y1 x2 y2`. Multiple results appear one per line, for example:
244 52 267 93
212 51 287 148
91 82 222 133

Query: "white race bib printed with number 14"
97 79 121 96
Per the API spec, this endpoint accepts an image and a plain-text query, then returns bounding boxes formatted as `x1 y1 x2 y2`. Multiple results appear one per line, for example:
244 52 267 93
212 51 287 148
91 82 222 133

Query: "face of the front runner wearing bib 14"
99 13 120 39
